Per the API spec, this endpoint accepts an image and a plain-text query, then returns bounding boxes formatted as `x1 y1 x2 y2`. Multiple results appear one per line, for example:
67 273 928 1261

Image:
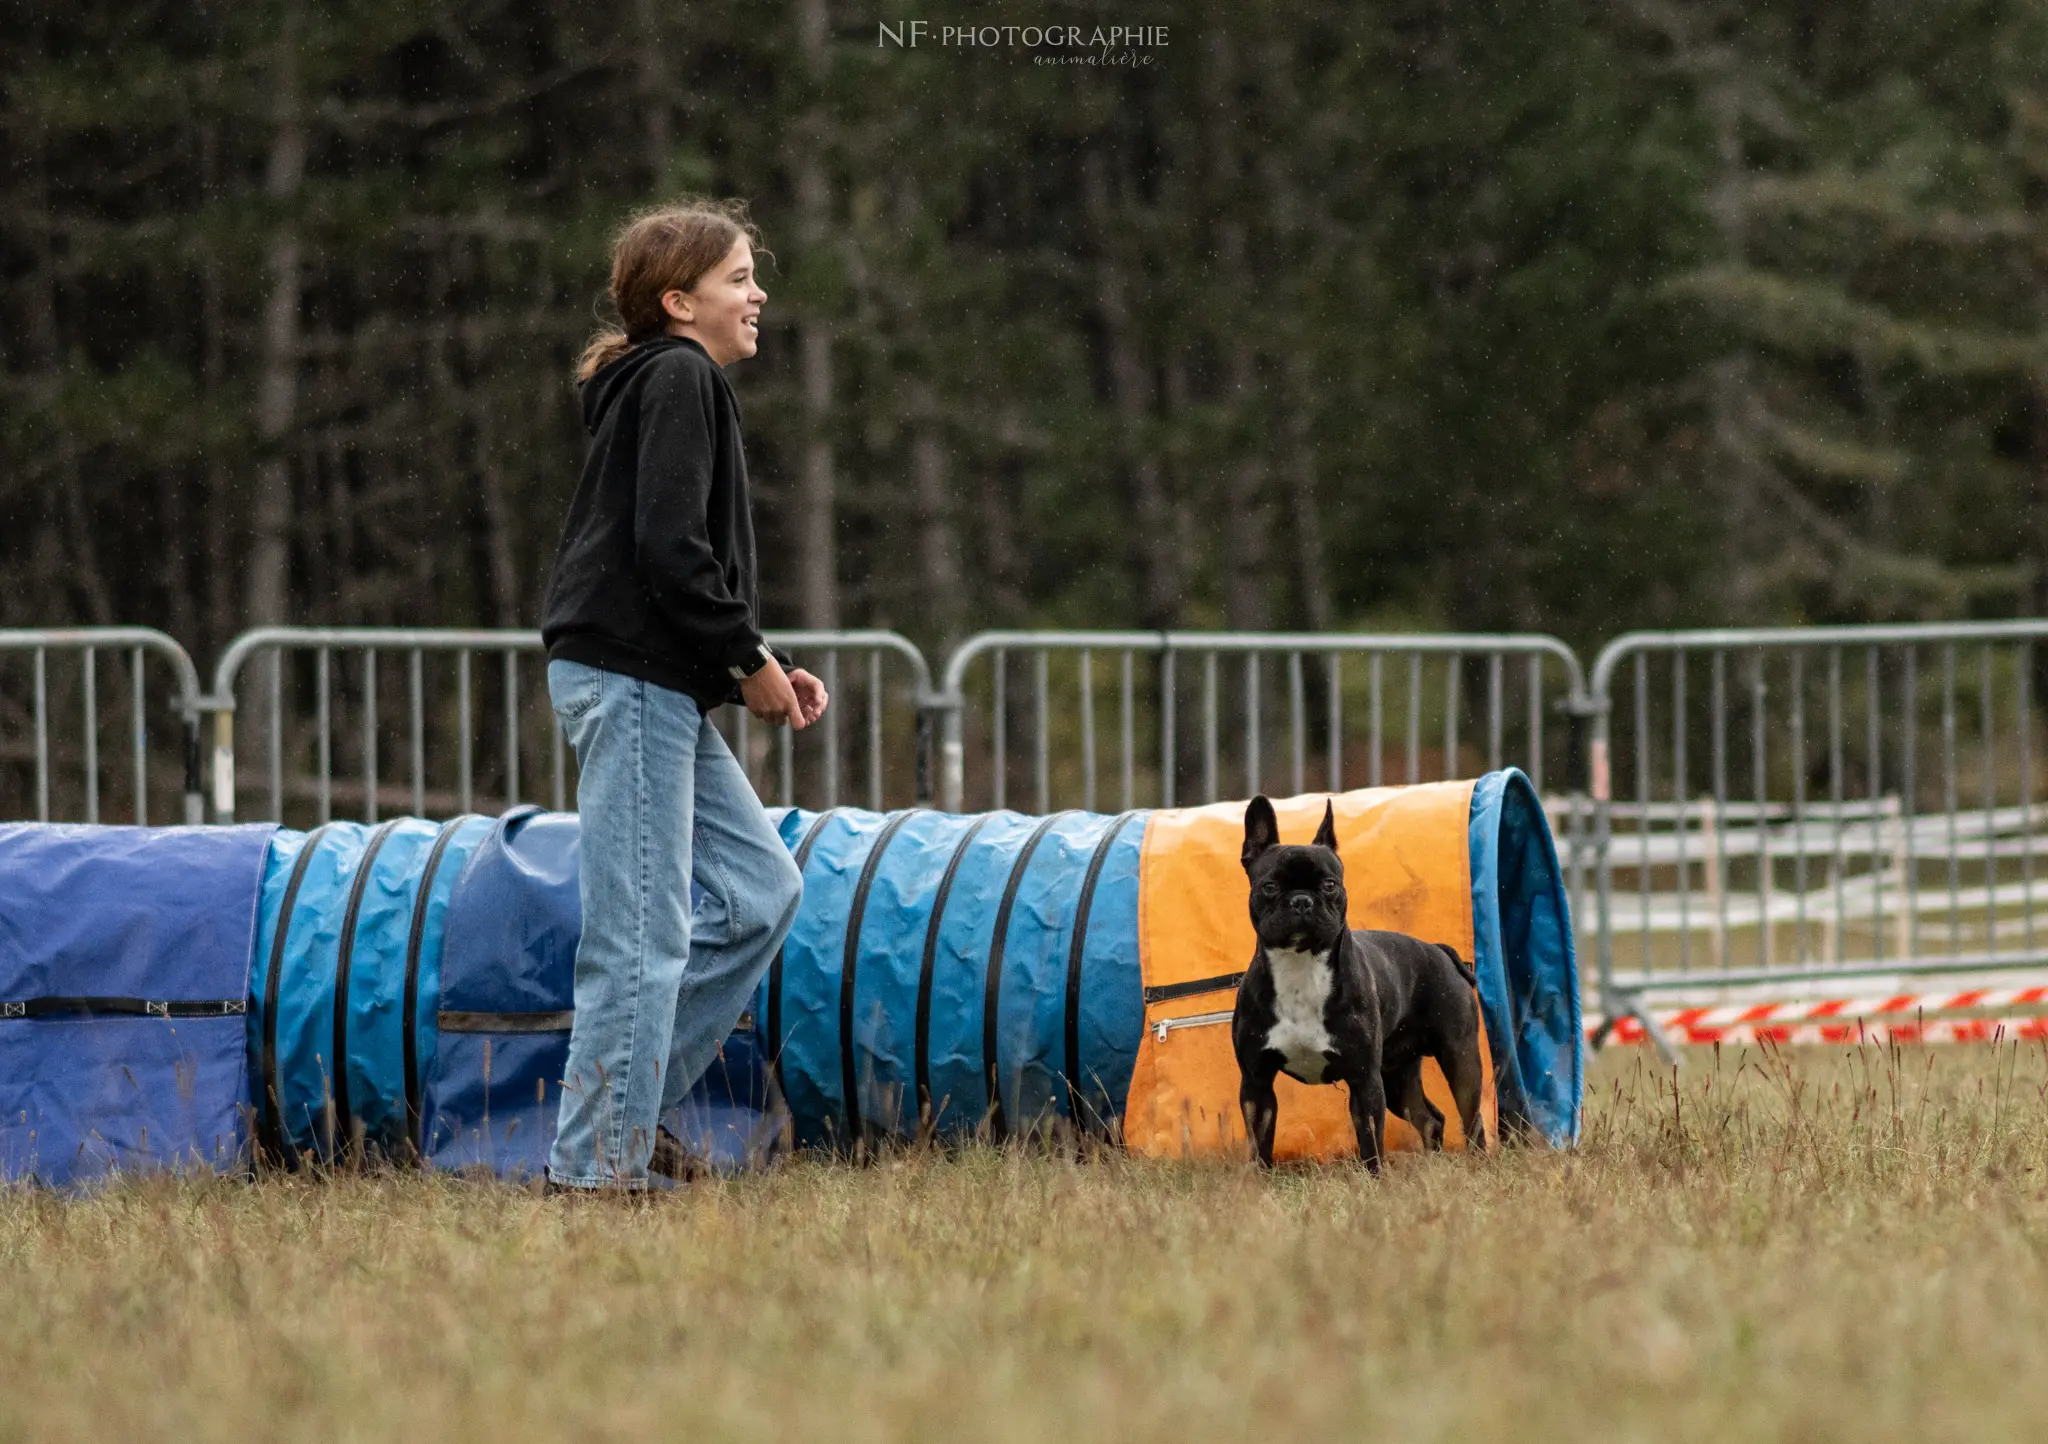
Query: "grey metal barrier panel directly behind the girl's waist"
203 627 930 821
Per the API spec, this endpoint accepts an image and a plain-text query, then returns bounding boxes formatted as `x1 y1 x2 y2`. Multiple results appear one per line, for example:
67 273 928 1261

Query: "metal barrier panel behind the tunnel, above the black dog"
934 631 1585 815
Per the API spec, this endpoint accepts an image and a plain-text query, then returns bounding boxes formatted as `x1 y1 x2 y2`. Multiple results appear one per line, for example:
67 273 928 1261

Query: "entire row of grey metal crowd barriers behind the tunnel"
19 619 2048 1036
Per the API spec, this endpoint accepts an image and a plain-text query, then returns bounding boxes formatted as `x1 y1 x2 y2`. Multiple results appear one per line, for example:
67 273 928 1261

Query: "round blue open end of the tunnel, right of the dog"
1470 768 1585 1147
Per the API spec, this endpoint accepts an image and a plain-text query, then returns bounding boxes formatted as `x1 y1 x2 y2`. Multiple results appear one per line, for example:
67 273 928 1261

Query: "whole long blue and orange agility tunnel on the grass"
0 770 1583 1184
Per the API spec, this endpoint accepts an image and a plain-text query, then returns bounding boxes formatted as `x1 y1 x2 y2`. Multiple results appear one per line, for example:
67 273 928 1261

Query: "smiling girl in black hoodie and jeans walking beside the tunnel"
541 201 827 1192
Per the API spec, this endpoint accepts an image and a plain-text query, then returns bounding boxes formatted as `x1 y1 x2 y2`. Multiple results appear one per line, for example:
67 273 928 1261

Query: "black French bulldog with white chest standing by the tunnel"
1231 797 1485 1174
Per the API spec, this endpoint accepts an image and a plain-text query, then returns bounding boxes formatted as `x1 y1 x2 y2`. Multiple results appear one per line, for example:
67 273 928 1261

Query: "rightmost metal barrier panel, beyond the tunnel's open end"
1591 621 2048 1032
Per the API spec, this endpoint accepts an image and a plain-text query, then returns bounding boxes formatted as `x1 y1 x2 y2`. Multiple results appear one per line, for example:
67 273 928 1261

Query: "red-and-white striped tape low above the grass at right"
1585 983 2048 1045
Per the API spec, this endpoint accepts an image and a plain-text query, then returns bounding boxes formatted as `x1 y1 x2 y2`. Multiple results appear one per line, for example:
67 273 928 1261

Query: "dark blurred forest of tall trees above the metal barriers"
0 0 2048 660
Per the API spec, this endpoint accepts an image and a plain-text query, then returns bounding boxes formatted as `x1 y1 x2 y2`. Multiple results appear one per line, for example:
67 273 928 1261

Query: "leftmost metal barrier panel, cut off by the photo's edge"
0 627 205 823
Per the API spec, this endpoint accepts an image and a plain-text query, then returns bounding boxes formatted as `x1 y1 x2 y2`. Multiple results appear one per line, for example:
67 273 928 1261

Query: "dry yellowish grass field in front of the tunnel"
0 1047 2048 1444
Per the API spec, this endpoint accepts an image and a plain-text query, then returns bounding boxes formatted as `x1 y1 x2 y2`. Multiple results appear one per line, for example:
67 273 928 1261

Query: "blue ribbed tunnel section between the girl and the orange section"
758 809 1145 1149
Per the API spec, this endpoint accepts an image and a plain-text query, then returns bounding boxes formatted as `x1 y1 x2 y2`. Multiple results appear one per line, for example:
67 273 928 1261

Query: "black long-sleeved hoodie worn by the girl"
541 336 788 711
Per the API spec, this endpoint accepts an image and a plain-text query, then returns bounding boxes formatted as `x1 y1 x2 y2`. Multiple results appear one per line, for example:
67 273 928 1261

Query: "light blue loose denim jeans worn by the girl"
547 662 803 1188
